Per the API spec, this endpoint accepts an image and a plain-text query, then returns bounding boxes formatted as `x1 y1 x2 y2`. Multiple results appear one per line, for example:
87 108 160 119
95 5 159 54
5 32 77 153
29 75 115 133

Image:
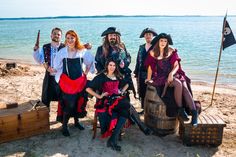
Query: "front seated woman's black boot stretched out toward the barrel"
130 105 152 135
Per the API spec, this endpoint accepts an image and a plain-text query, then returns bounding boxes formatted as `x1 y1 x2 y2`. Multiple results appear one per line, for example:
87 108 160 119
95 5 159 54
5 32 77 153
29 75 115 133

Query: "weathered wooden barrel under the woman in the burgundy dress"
144 85 179 136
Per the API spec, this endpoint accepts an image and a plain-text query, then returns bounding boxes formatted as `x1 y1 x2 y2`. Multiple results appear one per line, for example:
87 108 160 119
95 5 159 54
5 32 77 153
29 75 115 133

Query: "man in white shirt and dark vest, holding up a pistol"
33 27 65 107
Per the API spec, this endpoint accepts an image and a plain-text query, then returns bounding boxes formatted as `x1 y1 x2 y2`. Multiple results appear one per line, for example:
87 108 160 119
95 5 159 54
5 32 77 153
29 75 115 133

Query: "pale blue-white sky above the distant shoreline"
0 0 236 18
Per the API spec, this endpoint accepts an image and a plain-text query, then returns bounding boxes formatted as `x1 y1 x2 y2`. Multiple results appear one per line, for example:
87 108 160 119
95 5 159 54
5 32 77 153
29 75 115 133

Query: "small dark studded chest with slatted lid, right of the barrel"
179 113 226 147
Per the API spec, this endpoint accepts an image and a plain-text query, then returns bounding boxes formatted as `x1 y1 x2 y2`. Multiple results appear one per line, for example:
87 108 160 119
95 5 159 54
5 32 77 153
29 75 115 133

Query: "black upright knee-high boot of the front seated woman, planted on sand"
107 117 126 151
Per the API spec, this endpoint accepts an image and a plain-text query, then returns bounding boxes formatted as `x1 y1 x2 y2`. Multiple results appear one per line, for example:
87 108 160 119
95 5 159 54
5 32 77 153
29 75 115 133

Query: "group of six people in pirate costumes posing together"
33 27 198 151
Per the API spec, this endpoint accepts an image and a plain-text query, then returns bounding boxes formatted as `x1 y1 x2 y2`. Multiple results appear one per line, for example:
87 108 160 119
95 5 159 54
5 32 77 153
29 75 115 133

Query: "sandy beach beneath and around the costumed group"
0 60 236 157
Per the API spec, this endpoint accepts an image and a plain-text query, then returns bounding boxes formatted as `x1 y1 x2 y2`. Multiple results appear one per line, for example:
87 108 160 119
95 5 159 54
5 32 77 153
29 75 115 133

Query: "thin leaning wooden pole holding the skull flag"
204 12 227 110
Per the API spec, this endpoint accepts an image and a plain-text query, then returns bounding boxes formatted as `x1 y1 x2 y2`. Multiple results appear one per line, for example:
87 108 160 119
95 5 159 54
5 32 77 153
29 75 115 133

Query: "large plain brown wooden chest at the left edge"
0 101 50 143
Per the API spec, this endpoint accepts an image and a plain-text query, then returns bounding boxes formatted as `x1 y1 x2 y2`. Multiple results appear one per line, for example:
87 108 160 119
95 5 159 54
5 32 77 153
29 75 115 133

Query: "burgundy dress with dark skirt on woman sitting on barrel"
145 50 192 117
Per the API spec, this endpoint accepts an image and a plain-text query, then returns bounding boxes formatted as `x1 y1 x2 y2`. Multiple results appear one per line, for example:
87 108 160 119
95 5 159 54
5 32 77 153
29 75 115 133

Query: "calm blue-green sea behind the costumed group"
0 16 236 86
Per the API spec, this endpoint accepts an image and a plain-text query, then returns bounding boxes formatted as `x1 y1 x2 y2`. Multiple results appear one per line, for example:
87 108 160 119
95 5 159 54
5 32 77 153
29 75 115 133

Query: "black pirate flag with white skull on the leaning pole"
223 18 236 50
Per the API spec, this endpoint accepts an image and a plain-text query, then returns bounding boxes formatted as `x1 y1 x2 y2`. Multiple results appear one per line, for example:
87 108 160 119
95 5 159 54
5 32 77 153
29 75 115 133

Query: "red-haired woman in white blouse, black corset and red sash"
54 30 95 136
